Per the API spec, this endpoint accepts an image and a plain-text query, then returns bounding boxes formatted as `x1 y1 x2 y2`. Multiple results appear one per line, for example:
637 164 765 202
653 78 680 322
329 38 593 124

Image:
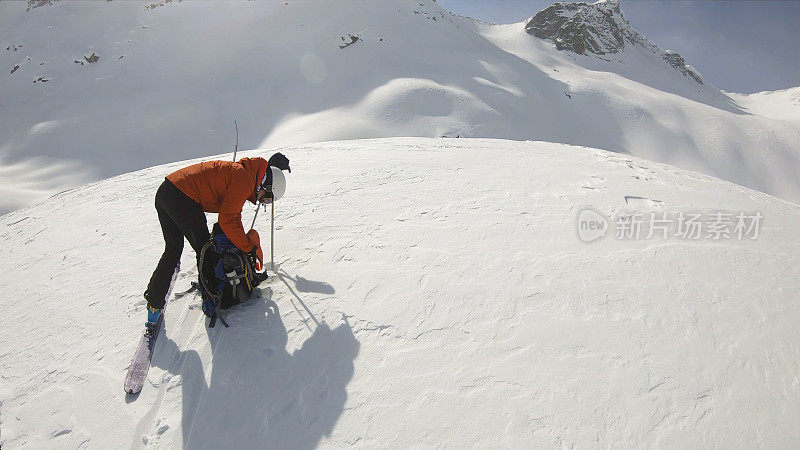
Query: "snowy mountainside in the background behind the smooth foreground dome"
0 0 800 212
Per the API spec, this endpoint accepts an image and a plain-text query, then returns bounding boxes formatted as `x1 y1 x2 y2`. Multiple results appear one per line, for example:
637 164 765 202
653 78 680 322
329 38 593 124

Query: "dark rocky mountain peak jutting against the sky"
525 0 703 84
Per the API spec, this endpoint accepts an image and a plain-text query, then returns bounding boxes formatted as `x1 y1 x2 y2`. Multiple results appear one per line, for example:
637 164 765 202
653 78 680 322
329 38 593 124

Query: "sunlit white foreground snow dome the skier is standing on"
0 138 800 448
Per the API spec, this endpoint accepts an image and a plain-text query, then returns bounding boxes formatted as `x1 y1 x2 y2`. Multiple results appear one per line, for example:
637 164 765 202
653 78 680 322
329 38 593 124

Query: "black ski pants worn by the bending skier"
144 179 210 309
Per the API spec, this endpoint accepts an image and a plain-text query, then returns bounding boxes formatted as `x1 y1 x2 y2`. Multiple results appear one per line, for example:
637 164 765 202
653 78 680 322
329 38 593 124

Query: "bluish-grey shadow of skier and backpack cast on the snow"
155 289 360 449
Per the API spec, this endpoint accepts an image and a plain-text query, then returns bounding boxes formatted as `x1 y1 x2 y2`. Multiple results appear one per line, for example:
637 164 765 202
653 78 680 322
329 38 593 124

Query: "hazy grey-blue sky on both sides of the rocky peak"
438 0 800 93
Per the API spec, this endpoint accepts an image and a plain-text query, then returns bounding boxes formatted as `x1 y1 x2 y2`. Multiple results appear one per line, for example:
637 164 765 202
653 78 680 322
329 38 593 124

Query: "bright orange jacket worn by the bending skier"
167 158 269 252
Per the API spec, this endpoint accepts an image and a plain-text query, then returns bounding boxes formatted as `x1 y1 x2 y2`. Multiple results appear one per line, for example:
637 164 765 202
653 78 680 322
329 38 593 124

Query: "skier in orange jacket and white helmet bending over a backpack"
144 153 292 330
